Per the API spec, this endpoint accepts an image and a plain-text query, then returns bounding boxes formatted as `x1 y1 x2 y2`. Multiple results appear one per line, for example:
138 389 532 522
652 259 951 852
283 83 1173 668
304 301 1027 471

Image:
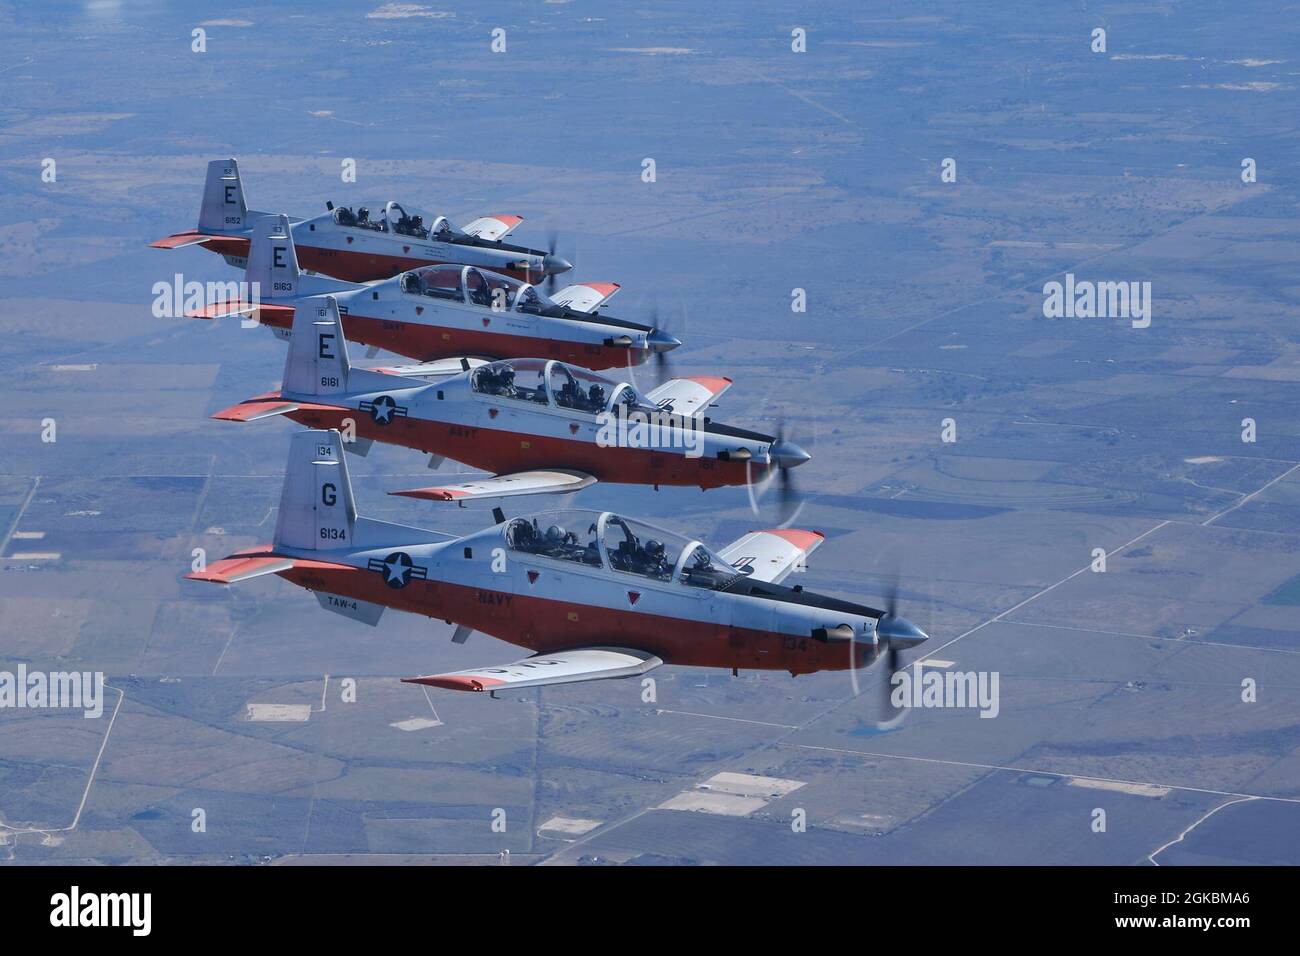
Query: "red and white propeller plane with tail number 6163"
189 216 681 368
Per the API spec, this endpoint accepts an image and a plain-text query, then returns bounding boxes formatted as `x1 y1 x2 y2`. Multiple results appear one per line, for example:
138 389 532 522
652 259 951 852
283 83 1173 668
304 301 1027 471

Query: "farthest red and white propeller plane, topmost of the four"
150 159 573 282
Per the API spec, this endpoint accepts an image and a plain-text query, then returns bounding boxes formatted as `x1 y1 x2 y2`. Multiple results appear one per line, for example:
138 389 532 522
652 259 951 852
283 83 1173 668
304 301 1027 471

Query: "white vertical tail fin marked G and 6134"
276 428 356 551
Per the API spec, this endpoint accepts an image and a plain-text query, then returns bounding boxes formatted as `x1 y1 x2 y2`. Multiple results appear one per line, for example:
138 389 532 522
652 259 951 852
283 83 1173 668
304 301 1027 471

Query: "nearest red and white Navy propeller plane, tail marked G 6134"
187 431 928 691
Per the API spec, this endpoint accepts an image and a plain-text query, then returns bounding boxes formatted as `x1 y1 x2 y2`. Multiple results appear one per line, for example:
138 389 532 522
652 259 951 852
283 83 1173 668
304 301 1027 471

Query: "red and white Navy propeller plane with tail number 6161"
212 295 810 503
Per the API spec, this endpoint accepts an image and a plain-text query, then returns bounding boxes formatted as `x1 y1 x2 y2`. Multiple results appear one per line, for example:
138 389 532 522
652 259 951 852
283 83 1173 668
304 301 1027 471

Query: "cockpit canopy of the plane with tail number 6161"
469 359 659 415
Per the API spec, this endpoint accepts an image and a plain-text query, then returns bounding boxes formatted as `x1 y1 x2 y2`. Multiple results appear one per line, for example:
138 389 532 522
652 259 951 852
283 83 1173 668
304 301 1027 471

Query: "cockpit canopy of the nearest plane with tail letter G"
503 510 745 589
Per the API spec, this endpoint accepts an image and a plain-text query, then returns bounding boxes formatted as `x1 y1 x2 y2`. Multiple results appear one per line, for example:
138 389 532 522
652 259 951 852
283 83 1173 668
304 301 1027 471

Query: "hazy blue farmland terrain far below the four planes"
0 0 1300 864
